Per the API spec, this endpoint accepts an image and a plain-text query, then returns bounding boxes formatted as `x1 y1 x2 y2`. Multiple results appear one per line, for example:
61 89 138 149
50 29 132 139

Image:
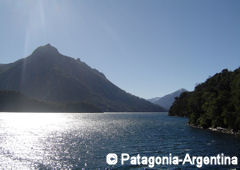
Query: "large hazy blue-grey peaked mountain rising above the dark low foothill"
0 44 163 112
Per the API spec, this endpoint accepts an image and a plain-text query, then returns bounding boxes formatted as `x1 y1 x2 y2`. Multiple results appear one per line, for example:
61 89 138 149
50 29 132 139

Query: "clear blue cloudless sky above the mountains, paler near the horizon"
0 0 240 98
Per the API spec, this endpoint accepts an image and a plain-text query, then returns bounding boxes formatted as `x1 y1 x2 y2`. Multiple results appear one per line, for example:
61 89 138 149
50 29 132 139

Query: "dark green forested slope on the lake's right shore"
169 68 240 131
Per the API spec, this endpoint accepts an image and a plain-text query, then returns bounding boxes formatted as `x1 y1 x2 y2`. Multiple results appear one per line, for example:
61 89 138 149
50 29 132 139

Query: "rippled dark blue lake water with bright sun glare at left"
0 113 240 169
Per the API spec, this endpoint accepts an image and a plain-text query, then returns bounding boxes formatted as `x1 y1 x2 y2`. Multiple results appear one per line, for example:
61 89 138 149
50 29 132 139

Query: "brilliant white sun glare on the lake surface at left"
0 113 73 169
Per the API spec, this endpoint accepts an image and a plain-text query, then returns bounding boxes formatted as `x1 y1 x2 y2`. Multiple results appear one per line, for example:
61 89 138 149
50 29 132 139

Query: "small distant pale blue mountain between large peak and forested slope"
148 89 187 110
